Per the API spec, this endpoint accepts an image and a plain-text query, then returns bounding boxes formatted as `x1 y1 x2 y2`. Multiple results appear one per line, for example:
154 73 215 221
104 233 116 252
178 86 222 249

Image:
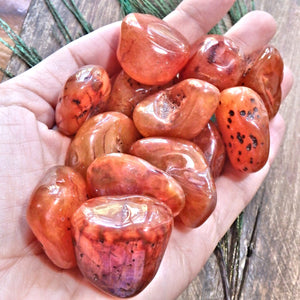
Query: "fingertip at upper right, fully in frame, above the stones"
225 11 276 55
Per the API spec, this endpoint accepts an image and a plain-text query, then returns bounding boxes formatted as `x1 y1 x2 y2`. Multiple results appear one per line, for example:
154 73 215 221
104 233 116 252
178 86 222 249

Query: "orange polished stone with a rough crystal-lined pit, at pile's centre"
133 79 220 139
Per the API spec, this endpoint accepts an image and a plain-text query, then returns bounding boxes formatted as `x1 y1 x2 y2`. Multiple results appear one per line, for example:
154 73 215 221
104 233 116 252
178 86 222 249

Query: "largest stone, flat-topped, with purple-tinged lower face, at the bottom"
72 195 173 298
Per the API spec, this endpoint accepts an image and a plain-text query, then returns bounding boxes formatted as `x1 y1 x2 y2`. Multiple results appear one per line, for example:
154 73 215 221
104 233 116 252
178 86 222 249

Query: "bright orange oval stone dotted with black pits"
216 87 270 173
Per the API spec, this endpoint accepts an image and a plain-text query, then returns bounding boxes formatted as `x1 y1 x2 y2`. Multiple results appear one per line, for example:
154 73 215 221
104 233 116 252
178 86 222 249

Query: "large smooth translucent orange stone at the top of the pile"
117 13 190 85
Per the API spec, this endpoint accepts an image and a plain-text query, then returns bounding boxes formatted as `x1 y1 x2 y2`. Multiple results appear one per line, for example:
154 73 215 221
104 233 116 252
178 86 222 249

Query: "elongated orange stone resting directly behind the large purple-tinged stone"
87 153 185 216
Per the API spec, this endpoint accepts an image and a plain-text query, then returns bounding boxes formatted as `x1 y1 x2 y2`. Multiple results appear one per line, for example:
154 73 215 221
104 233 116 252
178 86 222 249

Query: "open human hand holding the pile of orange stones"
0 0 292 299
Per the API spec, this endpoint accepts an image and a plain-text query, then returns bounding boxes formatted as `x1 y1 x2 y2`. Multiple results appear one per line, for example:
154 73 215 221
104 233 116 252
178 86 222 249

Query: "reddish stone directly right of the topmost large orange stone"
180 34 245 90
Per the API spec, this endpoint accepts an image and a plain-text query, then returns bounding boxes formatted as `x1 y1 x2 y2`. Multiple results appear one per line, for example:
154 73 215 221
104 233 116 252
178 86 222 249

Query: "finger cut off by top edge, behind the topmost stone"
164 0 234 44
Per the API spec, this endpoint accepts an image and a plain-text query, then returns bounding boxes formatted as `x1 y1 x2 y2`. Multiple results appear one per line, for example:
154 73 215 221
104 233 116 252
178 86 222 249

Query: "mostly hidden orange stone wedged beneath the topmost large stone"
107 70 171 117
